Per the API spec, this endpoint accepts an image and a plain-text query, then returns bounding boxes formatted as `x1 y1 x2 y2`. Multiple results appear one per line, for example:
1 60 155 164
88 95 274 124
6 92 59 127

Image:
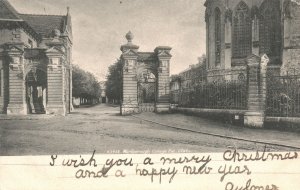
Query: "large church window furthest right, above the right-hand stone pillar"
259 0 281 56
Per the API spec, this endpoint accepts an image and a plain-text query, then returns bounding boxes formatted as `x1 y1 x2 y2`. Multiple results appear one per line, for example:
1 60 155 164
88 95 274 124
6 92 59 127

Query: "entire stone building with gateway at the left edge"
0 0 72 115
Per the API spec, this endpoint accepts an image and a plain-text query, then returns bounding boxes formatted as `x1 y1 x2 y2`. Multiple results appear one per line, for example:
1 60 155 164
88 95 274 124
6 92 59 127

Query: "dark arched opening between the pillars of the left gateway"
25 67 47 114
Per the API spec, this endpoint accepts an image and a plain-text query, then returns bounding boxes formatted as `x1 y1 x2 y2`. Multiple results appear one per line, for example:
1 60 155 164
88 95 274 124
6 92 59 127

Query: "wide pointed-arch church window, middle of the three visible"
232 1 252 58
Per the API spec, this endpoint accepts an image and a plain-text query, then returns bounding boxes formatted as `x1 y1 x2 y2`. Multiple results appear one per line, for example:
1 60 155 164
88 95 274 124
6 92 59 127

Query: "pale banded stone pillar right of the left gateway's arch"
45 48 66 116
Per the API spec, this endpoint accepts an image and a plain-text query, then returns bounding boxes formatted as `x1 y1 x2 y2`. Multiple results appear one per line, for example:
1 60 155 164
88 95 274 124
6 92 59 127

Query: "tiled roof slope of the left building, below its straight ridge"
20 14 66 37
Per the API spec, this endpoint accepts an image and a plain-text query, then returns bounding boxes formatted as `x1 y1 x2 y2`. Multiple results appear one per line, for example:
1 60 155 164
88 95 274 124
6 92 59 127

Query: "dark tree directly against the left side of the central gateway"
106 59 123 103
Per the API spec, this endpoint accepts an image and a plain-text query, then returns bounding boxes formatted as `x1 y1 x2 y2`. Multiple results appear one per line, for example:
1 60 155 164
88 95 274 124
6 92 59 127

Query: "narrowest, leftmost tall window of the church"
215 8 221 66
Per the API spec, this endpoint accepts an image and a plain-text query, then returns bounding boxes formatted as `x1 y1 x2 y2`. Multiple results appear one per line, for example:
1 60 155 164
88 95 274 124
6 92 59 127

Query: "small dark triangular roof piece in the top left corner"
0 0 22 21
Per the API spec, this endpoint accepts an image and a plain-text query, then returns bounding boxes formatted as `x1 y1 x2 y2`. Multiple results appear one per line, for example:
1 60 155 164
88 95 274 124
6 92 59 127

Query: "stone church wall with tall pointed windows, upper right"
205 0 300 79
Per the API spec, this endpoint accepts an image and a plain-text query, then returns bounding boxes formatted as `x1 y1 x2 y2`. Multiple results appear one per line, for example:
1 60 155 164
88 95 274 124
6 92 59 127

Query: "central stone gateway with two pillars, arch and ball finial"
120 32 172 115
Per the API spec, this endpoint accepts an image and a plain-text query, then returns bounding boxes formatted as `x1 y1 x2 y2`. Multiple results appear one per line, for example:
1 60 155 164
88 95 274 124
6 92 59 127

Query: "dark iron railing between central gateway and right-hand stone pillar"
171 77 248 109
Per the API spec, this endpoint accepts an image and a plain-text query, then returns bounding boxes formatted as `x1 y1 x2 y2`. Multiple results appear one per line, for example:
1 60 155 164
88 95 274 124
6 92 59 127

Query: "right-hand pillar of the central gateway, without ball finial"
154 47 172 113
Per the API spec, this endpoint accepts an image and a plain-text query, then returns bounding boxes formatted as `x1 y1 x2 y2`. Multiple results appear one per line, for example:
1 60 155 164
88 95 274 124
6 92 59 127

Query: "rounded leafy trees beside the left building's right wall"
72 65 101 100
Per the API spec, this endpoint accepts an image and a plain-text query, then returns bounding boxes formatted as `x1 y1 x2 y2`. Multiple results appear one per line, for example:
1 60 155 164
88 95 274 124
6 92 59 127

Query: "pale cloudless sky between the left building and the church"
9 0 206 80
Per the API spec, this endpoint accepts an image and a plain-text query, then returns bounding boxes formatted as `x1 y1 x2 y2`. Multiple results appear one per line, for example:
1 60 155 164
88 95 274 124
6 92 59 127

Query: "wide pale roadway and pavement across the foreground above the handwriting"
0 105 300 155
